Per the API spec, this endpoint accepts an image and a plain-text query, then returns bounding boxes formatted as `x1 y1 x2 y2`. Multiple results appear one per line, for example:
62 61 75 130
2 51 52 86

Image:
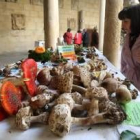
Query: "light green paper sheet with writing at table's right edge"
123 101 140 126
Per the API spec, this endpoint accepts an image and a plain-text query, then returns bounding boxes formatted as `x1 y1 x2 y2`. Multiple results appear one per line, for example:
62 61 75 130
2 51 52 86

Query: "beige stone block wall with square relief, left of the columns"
0 0 44 54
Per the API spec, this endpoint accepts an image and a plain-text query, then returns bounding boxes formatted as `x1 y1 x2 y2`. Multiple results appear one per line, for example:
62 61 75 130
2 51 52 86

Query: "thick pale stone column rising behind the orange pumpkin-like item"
44 0 59 50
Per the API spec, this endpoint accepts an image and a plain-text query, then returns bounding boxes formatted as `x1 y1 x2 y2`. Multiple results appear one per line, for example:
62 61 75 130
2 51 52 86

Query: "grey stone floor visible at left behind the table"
0 52 28 68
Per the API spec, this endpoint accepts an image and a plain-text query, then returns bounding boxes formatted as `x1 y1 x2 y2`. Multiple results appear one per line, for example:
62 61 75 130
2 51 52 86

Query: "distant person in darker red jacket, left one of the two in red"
63 28 72 45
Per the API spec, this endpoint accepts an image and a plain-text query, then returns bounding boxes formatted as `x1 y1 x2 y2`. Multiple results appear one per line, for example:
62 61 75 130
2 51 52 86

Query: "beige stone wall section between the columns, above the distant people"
59 0 100 36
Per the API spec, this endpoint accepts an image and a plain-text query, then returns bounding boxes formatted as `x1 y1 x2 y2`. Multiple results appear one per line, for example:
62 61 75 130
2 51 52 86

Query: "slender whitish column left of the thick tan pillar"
99 0 106 51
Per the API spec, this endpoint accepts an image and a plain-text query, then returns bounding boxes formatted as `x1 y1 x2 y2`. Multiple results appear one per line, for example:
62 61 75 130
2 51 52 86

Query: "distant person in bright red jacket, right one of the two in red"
74 30 82 46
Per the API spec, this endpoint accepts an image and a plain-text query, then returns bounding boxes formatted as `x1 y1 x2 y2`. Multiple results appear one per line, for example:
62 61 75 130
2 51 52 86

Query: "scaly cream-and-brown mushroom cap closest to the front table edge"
48 104 72 136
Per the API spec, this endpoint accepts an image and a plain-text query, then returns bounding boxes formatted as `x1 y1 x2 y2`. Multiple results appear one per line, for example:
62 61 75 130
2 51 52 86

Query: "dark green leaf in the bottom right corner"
120 130 140 140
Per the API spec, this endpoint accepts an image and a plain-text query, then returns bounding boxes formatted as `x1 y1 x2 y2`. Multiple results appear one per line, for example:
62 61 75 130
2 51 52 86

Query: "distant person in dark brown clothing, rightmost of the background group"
91 27 99 49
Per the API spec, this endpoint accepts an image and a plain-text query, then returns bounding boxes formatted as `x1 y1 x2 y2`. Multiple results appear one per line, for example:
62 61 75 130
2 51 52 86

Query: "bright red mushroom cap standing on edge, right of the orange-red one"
21 59 37 96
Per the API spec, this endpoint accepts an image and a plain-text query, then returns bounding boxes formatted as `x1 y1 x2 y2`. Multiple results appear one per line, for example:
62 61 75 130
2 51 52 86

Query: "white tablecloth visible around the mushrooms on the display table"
0 50 140 140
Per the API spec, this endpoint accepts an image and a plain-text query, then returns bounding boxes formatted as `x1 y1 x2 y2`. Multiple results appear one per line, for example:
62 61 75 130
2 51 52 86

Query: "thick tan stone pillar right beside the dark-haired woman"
103 0 123 67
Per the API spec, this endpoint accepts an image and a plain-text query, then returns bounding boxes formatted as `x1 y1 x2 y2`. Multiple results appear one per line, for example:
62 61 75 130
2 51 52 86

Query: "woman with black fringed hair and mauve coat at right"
118 4 140 90
